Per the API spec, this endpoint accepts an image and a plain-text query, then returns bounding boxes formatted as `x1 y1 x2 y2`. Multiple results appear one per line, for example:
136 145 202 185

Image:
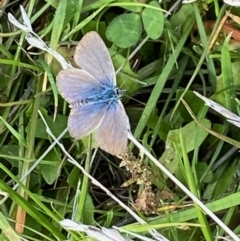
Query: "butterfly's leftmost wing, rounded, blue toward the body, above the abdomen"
56 69 101 103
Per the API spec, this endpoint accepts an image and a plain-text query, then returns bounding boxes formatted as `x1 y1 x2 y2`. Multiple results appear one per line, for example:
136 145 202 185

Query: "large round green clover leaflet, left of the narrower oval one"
106 13 142 48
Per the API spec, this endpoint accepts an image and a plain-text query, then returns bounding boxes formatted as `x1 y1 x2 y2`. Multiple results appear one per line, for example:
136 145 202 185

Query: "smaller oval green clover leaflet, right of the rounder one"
142 1 164 39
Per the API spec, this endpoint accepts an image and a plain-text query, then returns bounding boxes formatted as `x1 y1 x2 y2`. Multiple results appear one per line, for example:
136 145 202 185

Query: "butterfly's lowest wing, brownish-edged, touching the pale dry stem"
95 101 130 156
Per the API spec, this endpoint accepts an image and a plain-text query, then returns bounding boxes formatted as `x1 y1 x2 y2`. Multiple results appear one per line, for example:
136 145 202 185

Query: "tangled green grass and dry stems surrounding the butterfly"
0 0 240 241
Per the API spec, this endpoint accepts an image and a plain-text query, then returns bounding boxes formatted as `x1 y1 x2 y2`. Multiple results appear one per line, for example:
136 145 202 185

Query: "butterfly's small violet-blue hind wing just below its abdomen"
68 103 107 140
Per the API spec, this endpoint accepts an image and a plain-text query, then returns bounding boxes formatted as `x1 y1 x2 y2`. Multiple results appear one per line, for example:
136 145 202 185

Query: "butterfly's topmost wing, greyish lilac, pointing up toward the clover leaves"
74 31 116 85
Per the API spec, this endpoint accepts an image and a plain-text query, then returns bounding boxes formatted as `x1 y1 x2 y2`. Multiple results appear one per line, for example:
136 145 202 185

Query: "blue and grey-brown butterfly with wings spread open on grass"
56 31 130 155
